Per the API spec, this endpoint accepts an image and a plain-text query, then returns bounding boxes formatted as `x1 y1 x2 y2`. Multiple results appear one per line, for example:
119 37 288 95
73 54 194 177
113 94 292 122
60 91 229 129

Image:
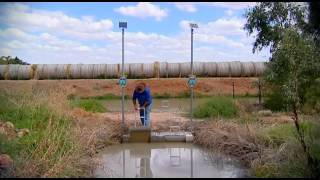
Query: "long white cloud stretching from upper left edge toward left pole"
0 4 113 35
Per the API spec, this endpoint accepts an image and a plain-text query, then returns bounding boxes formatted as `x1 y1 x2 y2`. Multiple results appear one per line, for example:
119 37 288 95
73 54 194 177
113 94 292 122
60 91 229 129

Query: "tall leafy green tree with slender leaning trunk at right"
244 2 320 177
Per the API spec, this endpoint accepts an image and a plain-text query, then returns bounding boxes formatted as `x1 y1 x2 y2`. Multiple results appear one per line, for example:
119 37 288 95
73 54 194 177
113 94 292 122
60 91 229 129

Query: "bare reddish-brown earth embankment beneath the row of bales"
0 78 258 97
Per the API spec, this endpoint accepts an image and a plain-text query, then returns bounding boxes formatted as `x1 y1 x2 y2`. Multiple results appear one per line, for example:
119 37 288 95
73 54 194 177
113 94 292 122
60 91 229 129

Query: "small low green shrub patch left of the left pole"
71 99 107 112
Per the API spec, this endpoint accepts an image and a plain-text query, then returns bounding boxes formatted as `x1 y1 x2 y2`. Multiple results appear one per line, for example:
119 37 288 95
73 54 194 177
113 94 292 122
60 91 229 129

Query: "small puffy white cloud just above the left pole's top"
115 2 168 21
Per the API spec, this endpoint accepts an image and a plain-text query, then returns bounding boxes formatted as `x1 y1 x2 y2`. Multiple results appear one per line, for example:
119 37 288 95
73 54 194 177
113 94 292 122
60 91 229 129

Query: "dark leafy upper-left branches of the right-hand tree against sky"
244 2 307 53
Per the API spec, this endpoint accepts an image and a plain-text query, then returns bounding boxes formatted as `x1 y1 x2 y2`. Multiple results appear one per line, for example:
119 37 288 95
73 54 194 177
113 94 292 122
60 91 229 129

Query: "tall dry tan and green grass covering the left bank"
0 81 119 177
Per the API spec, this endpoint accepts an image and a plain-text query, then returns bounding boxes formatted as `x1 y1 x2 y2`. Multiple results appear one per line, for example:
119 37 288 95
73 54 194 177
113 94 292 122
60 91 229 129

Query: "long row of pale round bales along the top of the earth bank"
0 61 265 80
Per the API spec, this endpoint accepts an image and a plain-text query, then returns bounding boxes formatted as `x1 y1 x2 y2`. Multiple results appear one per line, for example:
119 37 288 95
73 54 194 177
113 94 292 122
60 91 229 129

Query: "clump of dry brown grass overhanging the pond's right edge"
194 121 262 166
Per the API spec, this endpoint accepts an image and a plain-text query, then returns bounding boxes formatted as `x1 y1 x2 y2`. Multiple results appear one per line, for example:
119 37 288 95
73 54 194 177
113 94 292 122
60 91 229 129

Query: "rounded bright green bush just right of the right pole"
194 97 238 118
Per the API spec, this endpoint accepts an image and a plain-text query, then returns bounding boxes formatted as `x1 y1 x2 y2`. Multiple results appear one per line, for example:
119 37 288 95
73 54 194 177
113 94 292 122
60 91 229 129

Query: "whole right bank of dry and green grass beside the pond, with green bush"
190 97 320 178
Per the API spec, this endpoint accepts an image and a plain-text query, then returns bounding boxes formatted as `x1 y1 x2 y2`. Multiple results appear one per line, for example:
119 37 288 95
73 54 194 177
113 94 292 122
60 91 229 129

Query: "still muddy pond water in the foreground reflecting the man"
94 143 245 178
